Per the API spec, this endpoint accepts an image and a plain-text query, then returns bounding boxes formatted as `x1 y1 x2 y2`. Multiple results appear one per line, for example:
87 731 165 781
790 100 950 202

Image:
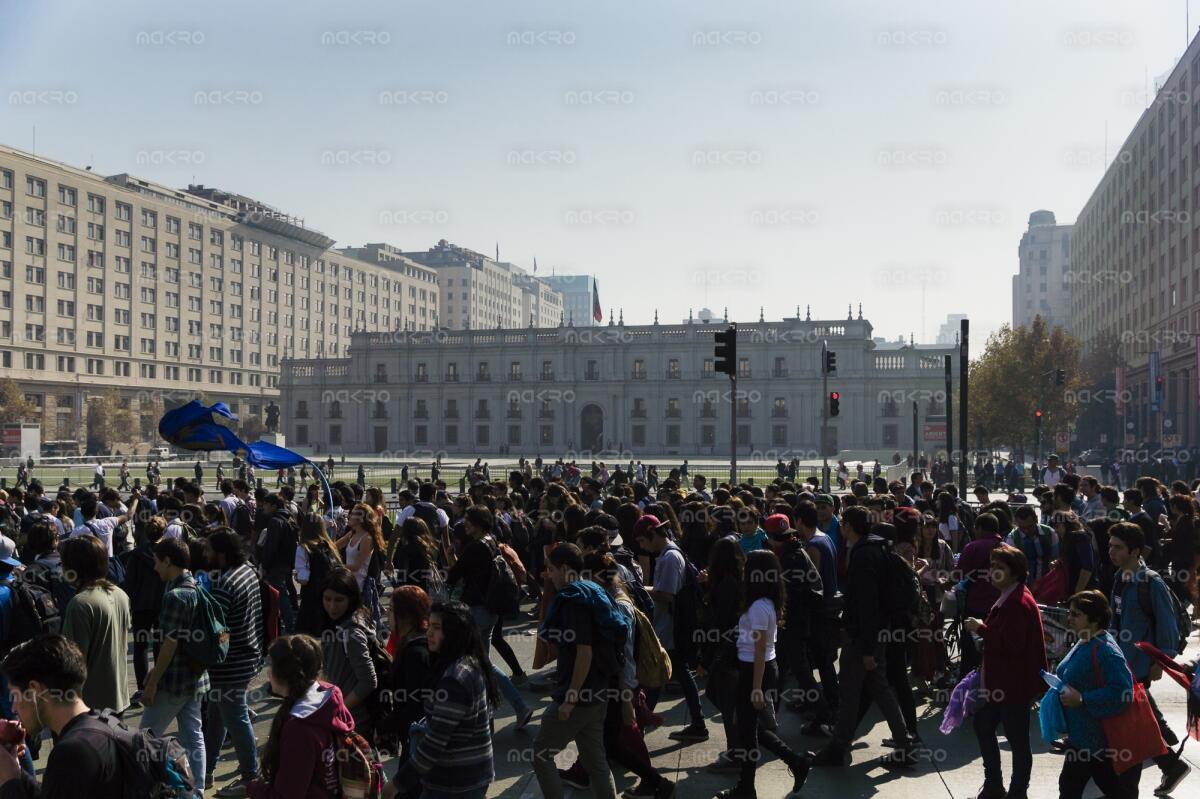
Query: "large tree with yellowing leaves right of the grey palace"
968 317 1086 452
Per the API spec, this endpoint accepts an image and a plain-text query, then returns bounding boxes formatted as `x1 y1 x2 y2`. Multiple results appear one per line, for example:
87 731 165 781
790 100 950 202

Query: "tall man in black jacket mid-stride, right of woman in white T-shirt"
814 506 913 767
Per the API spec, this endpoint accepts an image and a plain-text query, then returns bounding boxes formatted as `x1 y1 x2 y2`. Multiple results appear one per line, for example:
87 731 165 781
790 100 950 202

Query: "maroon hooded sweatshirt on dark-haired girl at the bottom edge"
248 680 354 799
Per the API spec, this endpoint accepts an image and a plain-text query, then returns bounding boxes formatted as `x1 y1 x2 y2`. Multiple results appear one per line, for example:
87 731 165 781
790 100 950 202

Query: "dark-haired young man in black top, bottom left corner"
0 636 127 799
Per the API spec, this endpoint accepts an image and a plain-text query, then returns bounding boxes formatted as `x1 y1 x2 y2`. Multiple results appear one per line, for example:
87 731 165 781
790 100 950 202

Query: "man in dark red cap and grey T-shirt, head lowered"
634 513 708 743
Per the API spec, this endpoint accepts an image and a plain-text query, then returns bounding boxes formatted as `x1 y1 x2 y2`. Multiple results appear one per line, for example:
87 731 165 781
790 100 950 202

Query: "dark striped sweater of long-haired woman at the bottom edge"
410 656 494 793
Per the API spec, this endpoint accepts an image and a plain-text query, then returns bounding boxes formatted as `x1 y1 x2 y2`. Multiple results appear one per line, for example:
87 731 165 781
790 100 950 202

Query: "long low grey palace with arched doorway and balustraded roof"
280 316 958 459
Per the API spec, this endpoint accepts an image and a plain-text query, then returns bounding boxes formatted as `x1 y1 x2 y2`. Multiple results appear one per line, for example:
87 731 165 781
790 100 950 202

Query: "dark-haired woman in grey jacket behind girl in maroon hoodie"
320 569 379 738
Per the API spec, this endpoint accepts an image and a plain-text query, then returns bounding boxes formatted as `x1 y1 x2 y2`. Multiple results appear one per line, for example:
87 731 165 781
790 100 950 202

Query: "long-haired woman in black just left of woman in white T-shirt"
701 537 745 771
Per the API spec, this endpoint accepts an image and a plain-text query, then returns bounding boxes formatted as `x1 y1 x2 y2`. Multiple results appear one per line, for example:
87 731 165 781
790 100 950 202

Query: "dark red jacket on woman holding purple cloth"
979 585 1046 705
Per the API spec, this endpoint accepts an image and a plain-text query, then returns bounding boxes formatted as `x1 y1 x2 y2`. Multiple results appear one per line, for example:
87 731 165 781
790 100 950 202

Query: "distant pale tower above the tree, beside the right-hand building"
1013 211 1075 328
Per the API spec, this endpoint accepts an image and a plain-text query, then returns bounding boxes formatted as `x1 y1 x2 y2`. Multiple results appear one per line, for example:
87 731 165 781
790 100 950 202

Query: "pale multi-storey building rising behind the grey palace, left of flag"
364 239 564 330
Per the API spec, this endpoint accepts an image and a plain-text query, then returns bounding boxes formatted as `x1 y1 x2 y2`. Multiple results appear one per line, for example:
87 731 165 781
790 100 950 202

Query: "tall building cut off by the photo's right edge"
1070 29 1200 446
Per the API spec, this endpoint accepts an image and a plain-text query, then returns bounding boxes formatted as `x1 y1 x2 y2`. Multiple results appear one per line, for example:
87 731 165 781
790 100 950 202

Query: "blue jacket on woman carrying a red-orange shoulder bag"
1055 631 1133 752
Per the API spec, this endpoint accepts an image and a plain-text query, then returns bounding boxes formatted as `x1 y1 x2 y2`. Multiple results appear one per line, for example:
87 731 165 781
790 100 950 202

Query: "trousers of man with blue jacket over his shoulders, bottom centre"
533 702 617 799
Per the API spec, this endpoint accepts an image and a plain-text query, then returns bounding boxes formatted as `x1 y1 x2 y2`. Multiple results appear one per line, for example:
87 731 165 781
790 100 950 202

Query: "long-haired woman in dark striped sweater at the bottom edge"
384 602 499 799
